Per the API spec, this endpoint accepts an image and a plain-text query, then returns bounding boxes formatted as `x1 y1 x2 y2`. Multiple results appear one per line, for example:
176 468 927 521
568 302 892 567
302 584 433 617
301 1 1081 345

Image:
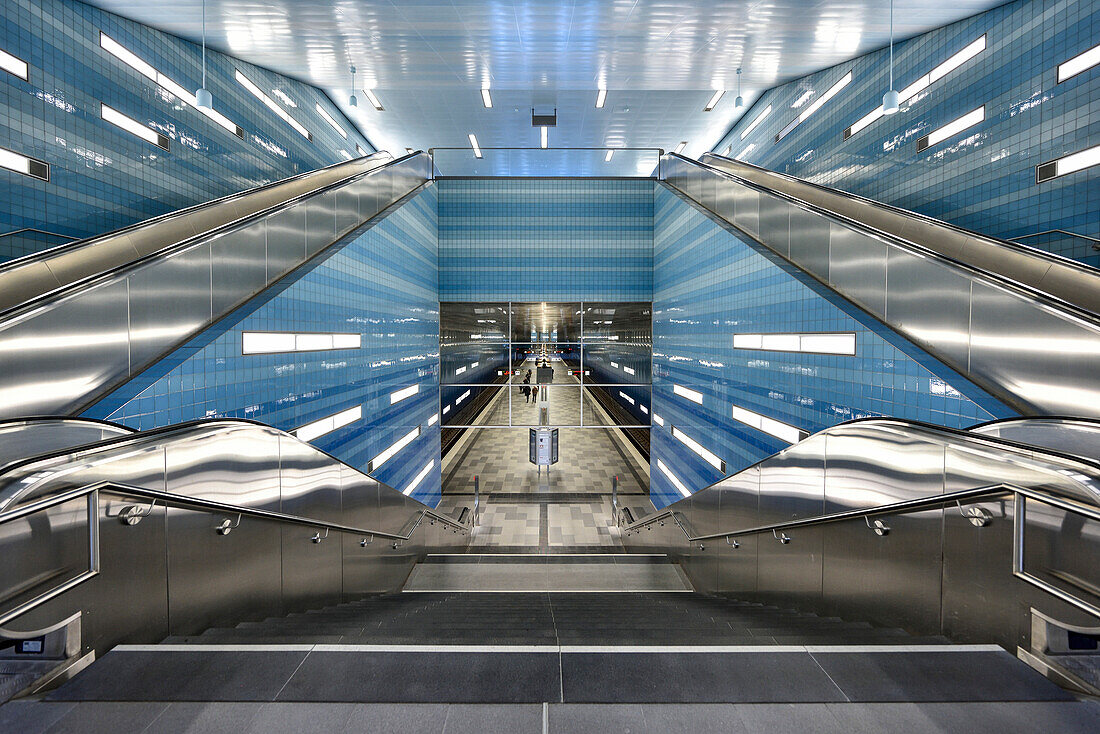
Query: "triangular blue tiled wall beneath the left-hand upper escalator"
86 186 440 505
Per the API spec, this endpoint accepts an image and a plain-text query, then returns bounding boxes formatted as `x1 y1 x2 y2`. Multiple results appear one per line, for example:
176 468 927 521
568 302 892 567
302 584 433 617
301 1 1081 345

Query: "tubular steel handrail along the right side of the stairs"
623 483 1100 617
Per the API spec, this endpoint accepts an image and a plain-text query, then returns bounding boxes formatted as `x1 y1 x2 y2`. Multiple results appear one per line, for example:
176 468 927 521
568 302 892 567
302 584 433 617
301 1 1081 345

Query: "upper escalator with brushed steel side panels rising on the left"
0 153 431 418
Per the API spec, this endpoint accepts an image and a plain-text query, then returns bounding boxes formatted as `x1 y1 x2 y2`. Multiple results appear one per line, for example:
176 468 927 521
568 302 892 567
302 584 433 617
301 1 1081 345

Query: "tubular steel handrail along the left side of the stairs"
0 481 470 626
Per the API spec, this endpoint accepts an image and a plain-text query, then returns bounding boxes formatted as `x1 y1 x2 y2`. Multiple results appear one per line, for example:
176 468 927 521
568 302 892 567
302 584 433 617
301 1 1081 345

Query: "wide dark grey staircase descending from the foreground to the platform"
0 555 1100 733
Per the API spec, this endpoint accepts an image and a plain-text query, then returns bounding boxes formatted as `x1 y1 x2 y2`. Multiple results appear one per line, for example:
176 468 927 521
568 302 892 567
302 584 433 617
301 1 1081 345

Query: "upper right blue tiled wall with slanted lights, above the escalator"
712 0 1100 265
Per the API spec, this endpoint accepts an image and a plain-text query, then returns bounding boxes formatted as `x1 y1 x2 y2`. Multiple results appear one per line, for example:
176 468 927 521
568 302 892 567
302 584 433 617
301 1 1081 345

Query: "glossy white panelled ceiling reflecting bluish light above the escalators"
83 0 1001 156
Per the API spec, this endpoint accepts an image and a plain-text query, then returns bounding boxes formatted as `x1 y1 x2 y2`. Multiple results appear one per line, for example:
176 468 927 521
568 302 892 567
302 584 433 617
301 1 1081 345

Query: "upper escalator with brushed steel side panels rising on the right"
662 154 1100 418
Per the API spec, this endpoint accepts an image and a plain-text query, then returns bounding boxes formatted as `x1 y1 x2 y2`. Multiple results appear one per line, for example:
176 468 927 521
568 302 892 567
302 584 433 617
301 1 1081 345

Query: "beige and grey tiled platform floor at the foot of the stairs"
440 362 652 554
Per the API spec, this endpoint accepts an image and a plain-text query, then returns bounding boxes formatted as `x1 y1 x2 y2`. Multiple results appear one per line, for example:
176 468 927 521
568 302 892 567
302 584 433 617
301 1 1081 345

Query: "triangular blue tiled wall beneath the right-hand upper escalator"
650 185 1012 507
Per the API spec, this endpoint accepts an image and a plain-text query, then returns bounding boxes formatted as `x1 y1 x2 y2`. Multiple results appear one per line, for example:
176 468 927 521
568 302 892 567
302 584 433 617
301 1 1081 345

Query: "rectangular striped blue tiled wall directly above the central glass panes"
438 178 653 300
